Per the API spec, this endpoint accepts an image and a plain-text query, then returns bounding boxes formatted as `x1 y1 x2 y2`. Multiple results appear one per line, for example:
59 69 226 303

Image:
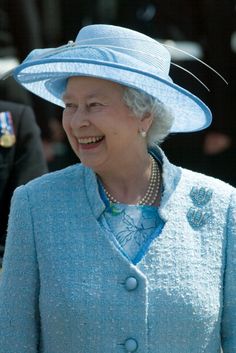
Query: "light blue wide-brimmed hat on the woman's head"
13 24 212 133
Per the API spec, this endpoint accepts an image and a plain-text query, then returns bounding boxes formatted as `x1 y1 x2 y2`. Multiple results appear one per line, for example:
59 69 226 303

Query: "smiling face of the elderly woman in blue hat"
63 77 152 172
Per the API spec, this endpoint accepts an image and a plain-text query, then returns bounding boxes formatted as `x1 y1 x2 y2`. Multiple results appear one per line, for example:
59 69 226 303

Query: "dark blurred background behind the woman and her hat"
0 0 236 186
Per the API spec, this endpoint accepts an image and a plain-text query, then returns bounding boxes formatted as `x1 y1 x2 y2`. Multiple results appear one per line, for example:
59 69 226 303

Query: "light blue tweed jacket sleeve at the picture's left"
0 186 39 353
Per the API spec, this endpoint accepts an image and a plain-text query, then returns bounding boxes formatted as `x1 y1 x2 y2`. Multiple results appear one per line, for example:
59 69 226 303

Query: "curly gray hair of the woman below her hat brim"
123 87 174 146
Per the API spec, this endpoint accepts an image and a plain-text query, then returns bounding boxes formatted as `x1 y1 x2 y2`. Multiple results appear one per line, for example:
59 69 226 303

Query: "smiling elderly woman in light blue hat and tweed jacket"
0 25 236 353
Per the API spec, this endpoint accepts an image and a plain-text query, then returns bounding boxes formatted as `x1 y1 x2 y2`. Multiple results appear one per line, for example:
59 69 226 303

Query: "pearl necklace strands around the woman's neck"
103 156 161 205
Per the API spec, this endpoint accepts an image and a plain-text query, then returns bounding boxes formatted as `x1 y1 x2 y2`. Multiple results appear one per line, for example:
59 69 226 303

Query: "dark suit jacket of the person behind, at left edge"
0 101 47 252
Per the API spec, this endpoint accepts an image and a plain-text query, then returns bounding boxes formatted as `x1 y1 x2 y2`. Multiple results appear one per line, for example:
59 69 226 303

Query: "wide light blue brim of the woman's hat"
14 58 212 133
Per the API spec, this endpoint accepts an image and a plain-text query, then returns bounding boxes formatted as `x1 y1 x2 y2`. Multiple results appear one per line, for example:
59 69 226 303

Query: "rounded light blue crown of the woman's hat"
75 24 171 79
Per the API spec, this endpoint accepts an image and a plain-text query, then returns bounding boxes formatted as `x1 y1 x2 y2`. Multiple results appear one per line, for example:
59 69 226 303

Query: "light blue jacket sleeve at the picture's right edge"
222 193 236 353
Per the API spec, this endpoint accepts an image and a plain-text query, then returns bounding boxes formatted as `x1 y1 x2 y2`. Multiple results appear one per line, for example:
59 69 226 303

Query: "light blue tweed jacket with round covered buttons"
0 147 236 353
